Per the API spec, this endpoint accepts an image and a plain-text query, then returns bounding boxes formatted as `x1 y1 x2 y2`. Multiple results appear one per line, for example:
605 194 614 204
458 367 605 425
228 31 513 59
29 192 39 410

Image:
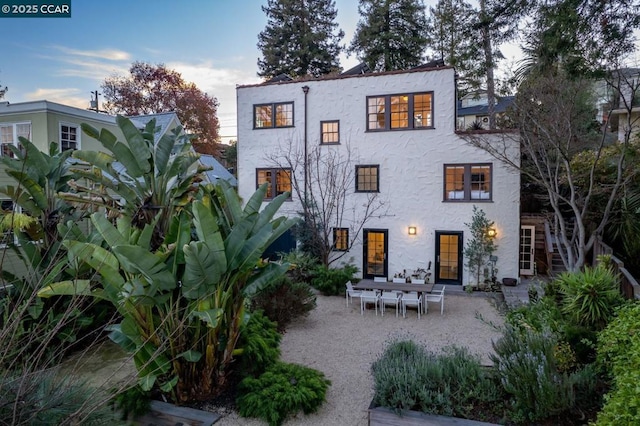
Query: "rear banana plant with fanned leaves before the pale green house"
61 116 203 248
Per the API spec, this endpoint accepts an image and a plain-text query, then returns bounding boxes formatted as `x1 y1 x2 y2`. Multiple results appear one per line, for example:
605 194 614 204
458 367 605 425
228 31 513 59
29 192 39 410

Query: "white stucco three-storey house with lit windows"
237 67 520 284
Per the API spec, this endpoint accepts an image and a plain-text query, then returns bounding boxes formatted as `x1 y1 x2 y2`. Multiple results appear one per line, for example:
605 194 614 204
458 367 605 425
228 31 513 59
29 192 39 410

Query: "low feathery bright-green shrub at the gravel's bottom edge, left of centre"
237 362 331 425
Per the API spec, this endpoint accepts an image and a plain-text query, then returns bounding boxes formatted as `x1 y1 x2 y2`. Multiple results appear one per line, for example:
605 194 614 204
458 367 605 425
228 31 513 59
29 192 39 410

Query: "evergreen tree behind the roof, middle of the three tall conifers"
349 0 427 71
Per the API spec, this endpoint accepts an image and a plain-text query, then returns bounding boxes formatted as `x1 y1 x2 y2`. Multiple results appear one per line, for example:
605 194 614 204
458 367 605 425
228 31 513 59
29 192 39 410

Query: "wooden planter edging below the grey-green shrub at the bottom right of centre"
369 407 496 426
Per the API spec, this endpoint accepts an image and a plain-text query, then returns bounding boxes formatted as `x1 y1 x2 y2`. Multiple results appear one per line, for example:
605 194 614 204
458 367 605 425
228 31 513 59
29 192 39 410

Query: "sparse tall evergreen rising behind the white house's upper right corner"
426 0 484 96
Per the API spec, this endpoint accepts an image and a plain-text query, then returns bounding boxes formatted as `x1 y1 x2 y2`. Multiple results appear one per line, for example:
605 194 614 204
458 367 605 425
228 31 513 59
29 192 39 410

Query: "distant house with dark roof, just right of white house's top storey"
456 91 515 130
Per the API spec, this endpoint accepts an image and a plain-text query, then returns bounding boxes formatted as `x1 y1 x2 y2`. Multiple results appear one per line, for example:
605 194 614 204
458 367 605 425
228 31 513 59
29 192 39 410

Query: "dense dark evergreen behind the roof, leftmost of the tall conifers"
258 0 344 78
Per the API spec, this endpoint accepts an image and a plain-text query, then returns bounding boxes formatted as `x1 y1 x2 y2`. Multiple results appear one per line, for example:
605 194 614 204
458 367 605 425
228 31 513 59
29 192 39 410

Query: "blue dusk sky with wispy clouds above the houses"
0 0 524 142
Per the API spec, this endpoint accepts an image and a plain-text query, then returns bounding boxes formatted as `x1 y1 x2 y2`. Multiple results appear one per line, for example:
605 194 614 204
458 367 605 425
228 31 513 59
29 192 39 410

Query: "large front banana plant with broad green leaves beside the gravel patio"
39 182 295 402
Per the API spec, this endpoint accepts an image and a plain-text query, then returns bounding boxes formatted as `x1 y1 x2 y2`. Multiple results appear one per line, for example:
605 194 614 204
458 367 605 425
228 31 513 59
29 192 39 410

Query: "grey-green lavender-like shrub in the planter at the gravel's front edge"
371 340 500 417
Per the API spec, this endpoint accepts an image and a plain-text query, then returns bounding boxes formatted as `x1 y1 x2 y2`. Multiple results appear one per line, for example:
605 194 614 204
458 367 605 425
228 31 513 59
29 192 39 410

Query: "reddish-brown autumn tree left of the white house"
101 62 220 155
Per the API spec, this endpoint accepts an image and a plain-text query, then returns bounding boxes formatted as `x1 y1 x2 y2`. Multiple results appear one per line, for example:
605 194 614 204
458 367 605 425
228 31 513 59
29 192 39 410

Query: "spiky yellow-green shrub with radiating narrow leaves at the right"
558 264 624 330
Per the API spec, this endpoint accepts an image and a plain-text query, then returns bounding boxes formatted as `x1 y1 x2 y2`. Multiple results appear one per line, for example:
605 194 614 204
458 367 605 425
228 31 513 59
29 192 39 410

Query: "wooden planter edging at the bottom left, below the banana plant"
135 401 220 426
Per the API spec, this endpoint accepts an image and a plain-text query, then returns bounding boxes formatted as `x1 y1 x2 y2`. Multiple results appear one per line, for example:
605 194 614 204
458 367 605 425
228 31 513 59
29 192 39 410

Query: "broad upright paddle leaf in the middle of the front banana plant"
182 241 227 299
